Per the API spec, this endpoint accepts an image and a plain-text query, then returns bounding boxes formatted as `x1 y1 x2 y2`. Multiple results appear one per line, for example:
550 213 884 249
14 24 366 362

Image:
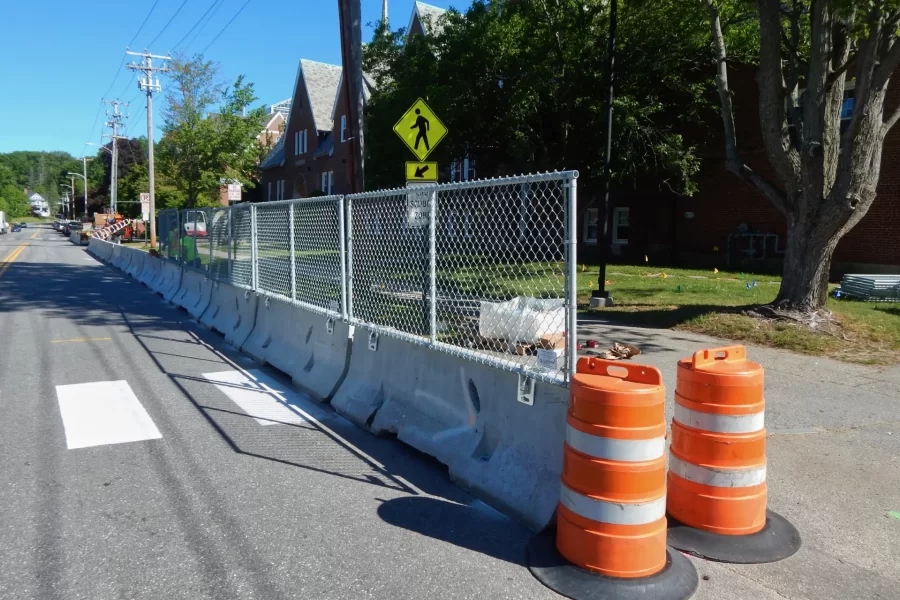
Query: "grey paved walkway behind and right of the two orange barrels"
578 319 900 600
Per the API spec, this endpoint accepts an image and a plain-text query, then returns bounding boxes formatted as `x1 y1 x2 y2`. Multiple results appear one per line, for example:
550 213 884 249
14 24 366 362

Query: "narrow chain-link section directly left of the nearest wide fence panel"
289 196 344 316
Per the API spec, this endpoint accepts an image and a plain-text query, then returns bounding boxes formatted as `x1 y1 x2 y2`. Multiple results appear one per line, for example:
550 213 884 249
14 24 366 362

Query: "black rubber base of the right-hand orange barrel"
666 510 801 564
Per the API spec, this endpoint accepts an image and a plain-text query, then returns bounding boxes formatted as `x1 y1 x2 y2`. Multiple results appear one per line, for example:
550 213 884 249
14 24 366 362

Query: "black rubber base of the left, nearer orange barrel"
527 535 699 600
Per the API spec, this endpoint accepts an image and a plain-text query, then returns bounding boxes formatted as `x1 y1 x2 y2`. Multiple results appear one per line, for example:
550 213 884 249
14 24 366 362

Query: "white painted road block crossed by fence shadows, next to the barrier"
203 369 328 425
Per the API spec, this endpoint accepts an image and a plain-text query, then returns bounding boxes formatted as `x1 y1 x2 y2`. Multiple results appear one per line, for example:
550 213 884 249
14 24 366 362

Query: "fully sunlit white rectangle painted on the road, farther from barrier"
56 381 162 450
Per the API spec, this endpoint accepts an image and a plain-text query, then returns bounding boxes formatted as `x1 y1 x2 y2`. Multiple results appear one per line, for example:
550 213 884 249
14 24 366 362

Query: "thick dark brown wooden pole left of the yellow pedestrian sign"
338 0 365 193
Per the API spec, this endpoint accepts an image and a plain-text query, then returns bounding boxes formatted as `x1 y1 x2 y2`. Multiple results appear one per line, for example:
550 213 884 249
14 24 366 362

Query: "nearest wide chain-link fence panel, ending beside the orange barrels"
346 172 577 381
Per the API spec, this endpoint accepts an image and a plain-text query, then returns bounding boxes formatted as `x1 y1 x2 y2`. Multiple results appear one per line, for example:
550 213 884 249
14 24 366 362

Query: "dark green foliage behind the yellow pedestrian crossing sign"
364 0 715 194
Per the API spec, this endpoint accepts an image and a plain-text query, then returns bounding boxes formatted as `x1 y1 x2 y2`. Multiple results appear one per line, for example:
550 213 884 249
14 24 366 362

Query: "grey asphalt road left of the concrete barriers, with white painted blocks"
0 228 557 600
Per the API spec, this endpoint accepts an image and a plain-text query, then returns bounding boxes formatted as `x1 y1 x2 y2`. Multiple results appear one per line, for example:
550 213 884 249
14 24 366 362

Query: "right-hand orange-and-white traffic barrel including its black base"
667 346 800 563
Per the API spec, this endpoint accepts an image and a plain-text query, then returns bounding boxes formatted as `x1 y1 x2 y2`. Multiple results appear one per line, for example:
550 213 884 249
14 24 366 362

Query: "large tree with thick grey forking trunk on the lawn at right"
702 0 900 313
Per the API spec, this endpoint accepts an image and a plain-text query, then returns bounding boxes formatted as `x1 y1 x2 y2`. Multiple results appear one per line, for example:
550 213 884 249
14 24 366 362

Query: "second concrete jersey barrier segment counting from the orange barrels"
241 297 350 402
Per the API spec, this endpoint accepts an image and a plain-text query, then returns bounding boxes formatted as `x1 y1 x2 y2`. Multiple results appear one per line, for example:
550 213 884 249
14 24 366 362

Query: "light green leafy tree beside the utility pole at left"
158 55 267 207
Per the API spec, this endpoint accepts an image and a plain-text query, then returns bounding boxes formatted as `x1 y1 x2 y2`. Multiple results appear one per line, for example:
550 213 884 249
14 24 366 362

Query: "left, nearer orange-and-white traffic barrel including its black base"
529 358 697 600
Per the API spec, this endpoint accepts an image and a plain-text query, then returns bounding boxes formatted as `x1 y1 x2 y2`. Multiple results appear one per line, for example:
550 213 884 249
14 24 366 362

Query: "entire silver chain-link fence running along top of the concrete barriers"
152 172 578 383
